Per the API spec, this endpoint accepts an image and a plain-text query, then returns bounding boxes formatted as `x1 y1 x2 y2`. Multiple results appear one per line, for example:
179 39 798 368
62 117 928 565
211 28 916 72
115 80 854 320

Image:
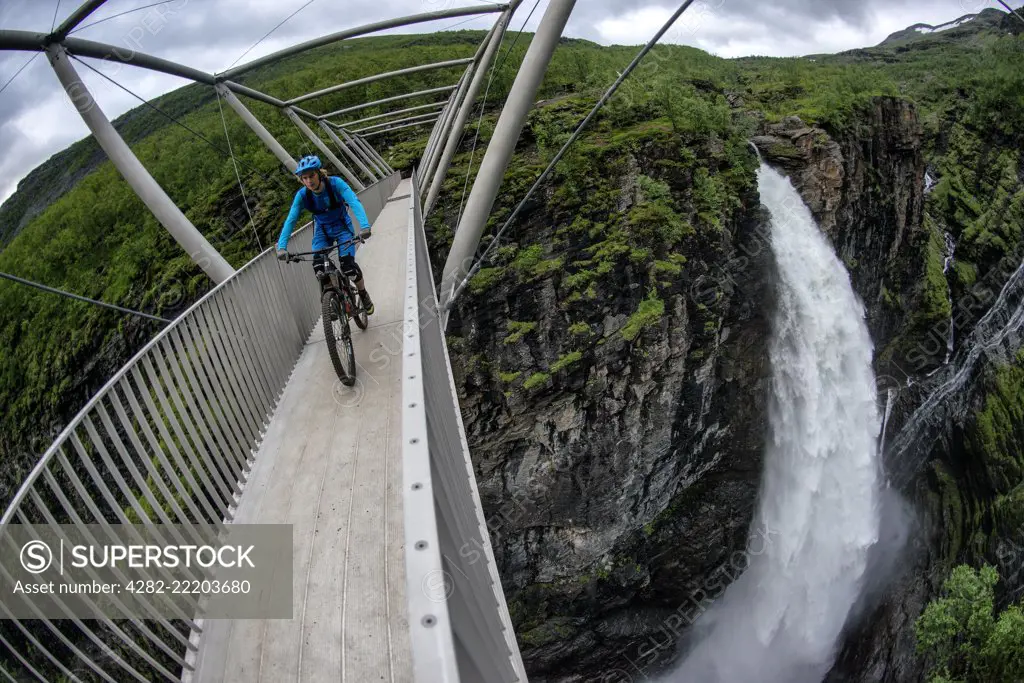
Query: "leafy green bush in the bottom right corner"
914 565 1024 683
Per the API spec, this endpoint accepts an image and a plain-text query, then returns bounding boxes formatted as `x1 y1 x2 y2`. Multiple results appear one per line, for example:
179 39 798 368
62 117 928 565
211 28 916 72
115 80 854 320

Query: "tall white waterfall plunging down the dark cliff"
667 164 881 683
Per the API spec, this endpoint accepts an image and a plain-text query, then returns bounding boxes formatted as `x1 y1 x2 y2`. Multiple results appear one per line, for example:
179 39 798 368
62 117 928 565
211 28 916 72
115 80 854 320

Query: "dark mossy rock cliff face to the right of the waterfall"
755 98 1024 683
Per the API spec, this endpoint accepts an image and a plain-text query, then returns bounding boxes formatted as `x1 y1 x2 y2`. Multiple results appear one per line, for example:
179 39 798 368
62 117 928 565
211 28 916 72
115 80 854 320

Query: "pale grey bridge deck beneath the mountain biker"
191 180 412 683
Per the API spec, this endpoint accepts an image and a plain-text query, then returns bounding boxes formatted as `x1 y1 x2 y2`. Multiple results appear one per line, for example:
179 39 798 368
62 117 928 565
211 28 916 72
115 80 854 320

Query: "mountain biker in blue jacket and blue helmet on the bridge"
278 156 374 315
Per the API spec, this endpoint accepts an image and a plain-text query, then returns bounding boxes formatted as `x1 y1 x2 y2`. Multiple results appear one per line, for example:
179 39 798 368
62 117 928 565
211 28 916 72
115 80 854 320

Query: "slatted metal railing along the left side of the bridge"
0 173 400 682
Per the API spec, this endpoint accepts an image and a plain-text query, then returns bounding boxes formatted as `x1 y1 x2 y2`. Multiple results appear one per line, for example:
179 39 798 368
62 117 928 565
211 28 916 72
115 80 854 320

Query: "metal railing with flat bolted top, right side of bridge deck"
402 171 526 683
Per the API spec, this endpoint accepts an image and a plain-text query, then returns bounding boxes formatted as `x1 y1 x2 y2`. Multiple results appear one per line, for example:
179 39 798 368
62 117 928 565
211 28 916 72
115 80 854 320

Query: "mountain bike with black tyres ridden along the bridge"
288 230 370 386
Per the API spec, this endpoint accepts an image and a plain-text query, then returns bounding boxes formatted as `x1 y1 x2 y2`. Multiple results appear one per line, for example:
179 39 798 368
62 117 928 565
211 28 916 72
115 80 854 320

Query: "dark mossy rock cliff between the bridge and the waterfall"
436 112 771 681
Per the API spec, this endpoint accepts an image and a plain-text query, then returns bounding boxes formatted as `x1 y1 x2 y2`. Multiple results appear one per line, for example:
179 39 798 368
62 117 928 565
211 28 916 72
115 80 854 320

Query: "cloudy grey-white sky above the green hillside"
0 0 1024 202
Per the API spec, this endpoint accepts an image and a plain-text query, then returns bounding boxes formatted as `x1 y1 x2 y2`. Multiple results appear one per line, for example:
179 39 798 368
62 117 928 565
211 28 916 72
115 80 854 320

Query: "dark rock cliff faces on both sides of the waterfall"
439 92 1024 681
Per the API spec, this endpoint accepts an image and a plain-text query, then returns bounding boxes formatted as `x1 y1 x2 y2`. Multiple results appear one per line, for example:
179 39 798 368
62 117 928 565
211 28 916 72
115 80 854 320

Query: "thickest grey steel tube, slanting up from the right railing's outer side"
439 0 575 313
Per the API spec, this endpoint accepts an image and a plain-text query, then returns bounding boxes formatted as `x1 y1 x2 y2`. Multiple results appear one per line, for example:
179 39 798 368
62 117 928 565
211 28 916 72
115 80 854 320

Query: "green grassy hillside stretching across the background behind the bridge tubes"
0 12 1024 511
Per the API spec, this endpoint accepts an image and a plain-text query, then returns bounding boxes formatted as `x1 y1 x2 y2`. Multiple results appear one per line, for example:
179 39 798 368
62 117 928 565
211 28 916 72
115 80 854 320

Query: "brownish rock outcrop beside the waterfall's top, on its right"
753 97 929 375
